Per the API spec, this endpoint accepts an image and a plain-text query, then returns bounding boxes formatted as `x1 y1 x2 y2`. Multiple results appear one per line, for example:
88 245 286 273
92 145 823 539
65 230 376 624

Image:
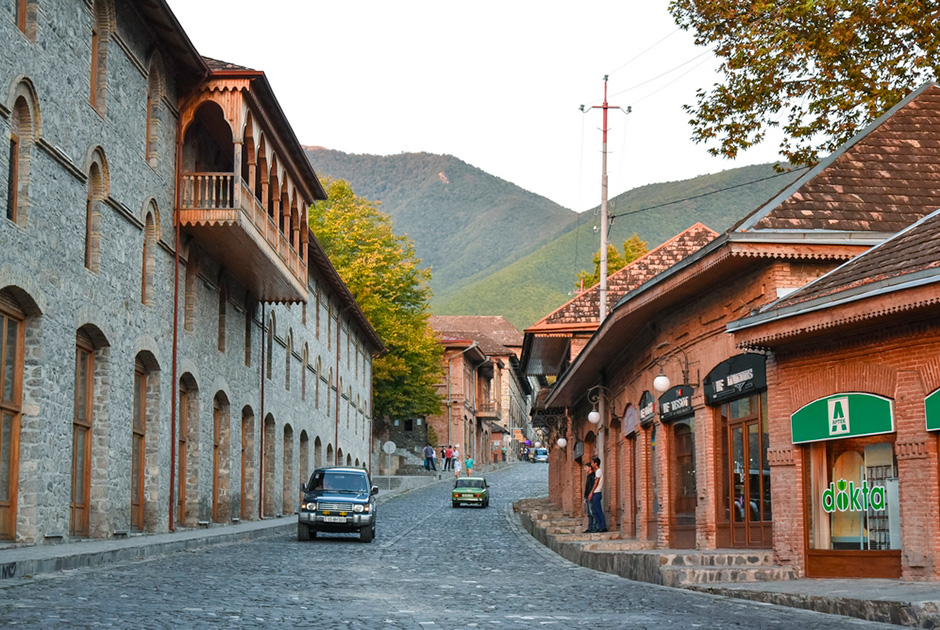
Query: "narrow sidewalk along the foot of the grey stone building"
0 475 450 588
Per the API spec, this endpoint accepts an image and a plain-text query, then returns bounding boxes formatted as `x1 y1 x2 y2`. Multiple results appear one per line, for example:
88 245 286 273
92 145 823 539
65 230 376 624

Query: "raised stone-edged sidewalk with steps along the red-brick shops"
514 498 940 628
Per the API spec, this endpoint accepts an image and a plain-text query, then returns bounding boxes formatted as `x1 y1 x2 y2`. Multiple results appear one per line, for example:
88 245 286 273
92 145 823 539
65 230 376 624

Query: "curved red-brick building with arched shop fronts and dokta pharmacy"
543 84 940 578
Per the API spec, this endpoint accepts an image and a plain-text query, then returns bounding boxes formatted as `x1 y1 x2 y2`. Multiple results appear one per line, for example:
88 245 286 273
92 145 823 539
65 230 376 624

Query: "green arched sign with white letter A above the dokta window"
790 393 894 444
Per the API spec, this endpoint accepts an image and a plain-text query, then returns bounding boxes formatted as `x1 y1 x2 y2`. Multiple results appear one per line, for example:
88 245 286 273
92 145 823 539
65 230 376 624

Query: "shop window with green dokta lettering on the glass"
809 438 901 551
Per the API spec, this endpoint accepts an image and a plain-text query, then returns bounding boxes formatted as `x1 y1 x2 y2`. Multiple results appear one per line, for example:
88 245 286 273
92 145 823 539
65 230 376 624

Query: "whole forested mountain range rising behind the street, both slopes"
306 147 800 329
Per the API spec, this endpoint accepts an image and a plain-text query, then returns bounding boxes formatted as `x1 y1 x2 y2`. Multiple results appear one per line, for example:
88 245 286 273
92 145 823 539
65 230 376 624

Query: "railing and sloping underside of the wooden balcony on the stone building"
178 173 308 302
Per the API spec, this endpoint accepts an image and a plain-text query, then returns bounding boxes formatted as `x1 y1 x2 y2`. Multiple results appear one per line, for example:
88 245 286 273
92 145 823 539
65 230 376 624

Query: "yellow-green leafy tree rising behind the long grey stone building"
310 179 443 418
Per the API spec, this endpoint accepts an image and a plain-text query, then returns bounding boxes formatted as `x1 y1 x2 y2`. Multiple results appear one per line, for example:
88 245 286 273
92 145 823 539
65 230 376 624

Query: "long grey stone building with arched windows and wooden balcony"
0 0 383 543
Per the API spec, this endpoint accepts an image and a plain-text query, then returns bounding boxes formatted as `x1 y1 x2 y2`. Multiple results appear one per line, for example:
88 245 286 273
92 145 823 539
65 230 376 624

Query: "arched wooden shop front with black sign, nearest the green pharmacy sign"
702 354 773 549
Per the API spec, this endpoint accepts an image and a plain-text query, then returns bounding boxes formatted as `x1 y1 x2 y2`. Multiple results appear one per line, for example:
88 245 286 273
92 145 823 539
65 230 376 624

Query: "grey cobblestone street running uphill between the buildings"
0 464 894 630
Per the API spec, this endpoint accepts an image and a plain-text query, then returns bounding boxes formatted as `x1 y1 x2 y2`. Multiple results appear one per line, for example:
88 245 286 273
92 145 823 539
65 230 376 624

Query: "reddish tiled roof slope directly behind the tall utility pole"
528 223 718 331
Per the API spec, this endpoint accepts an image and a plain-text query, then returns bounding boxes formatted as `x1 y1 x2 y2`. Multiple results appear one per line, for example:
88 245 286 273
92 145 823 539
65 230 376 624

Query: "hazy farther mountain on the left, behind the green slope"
305 147 578 304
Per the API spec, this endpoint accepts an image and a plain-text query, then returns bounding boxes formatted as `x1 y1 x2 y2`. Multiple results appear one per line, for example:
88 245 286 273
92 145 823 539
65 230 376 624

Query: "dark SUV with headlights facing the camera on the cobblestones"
297 466 379 542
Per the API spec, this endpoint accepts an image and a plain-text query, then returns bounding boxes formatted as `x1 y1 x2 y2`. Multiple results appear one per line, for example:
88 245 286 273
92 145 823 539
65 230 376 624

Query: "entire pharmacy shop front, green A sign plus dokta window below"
790 392 901 578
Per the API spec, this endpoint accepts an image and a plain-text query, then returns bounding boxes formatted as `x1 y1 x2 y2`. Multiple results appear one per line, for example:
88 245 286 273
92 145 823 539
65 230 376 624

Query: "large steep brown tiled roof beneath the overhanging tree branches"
735 83 940 233
